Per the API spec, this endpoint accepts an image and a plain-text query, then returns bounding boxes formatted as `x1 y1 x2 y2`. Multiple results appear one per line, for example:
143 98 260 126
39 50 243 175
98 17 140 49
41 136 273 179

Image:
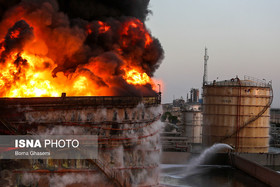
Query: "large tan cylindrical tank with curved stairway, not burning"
202 77 273 153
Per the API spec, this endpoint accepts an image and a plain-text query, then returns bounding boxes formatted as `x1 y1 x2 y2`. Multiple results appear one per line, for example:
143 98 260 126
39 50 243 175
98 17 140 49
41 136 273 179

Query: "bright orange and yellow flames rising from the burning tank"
0 15 159 97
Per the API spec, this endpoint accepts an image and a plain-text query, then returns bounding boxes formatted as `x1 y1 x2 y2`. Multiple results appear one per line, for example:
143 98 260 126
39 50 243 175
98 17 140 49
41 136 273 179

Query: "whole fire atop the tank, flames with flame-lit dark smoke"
0 4 163 97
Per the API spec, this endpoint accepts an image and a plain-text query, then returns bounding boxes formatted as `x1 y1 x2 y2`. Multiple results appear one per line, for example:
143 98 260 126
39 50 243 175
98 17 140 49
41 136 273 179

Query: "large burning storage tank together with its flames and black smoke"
0 0 164 186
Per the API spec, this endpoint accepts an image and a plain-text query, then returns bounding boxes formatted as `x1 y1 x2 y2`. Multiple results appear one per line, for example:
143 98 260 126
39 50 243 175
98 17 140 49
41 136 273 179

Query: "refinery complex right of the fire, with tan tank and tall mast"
162 48 277 153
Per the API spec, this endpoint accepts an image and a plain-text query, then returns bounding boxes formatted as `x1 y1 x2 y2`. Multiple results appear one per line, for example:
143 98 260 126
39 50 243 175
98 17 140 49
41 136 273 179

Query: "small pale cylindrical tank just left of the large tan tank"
183 110 202 143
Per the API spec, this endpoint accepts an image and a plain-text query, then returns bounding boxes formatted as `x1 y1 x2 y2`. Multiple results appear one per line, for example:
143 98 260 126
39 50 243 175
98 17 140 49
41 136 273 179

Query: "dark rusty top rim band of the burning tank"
0 96 160 110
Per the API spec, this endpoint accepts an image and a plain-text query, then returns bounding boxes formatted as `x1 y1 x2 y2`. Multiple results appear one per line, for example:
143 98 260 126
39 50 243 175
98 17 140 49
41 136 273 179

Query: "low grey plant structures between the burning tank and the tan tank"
161 88 203 152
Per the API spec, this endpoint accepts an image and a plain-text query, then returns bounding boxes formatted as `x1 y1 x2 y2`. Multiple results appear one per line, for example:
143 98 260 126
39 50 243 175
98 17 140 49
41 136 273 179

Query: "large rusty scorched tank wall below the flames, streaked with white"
0 94 161 186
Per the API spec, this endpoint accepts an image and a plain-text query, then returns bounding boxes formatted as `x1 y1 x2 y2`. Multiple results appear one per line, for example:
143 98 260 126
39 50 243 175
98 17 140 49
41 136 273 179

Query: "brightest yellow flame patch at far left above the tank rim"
0 53 61 97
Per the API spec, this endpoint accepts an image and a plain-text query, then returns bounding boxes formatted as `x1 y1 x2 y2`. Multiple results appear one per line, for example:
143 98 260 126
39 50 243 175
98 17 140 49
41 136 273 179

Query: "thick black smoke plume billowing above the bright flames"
0 0 164 95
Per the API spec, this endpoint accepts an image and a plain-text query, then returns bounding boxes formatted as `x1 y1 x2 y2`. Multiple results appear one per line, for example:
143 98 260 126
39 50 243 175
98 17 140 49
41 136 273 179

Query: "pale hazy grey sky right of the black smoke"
146 0 280 107
